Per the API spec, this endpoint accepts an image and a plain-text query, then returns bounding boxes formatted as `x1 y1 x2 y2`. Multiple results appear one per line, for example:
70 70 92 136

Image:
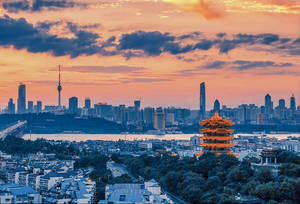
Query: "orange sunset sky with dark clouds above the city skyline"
0 0 300 109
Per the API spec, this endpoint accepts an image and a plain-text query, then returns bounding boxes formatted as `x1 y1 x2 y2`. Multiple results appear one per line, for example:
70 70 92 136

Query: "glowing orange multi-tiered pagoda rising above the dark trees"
200 112 234 154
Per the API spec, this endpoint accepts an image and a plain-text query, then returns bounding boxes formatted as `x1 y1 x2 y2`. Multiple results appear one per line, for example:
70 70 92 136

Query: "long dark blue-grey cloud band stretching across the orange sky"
0 15 300 60
